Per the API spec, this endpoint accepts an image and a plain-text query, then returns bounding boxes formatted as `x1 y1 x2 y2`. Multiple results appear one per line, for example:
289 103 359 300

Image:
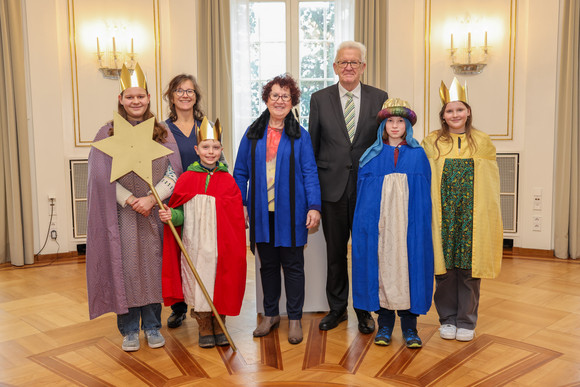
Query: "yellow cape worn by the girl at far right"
422 129 503 278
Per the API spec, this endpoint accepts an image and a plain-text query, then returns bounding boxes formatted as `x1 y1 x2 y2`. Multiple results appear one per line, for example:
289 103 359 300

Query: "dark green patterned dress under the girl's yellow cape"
441 159 474 270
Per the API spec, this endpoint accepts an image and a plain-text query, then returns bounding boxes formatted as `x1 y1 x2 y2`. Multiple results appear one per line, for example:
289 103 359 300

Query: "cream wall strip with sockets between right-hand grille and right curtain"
516 1 559 249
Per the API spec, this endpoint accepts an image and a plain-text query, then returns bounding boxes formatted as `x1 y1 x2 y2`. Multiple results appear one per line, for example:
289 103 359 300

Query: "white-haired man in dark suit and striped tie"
308 41 388 333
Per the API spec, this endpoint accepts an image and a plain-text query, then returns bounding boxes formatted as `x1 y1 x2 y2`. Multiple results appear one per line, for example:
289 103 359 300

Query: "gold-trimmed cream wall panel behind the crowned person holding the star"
67 0 163 147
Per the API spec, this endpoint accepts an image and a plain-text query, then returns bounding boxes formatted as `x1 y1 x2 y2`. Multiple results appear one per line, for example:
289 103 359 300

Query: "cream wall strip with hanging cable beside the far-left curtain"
25 0 75 254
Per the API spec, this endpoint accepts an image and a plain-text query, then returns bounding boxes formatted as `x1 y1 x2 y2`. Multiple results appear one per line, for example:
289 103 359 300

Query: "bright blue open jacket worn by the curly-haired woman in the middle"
234 127 321 247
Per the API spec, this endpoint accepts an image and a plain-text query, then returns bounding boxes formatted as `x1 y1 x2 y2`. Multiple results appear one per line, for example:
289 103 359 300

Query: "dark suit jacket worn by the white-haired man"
308 83 388 202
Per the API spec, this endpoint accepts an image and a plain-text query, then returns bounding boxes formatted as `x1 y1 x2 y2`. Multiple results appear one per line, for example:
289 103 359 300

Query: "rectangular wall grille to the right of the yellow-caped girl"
497 153 520 232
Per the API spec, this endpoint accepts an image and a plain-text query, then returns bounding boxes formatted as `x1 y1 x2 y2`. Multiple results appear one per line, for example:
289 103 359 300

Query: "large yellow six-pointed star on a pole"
92 112 173 186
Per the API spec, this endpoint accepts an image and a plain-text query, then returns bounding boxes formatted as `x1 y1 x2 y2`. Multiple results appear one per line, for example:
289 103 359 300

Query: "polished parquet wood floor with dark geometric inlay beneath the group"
0 252 580 387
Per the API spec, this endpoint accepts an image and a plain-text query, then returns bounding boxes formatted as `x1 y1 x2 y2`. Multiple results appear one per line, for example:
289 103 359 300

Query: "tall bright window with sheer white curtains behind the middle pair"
231 0 354 157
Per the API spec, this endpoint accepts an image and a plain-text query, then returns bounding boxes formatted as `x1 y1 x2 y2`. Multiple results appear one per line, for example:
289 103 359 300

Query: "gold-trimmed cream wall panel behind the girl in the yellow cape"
423 0 518 140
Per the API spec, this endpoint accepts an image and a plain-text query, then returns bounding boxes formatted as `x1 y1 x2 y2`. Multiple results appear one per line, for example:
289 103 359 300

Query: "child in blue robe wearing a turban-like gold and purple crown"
352 98 433 348
